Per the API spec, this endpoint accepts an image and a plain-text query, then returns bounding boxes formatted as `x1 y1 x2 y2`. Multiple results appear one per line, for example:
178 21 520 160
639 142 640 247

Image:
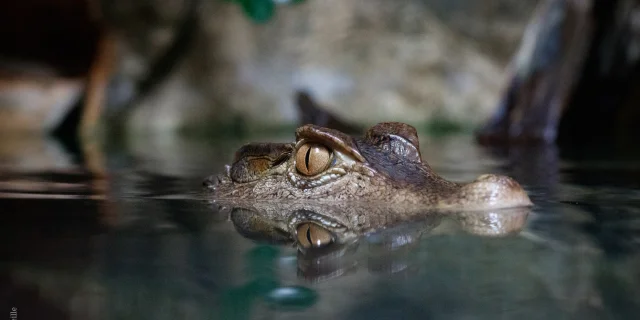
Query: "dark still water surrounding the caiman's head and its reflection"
0 136 640 319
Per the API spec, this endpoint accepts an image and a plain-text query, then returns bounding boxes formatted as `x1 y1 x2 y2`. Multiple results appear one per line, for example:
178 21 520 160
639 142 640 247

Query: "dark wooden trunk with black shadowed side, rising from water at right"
478 0 640 149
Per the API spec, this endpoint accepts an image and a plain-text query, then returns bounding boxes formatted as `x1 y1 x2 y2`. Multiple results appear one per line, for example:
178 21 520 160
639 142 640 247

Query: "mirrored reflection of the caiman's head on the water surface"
220 202 530 280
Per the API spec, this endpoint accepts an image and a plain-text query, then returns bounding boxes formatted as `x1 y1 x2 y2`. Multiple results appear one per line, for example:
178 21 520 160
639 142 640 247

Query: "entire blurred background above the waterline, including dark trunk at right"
0 0 640 143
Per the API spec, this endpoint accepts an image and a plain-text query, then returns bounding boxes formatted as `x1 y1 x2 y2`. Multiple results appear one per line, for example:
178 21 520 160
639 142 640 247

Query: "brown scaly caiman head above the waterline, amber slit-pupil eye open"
204 122 531 210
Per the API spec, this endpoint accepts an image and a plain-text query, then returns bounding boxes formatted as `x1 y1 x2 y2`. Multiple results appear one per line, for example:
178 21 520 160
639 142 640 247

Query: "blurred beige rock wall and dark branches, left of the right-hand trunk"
0 0 537 136
